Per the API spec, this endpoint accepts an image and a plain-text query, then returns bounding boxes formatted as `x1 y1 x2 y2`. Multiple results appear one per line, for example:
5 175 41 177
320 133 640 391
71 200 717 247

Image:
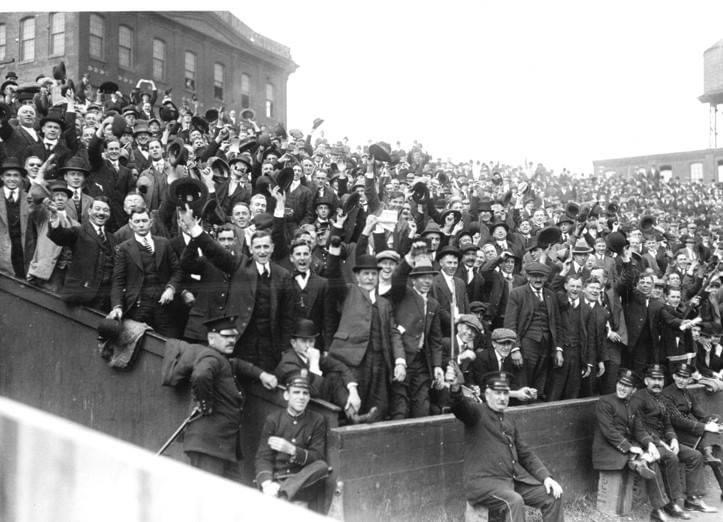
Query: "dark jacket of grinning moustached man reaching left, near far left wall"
48 221 118 304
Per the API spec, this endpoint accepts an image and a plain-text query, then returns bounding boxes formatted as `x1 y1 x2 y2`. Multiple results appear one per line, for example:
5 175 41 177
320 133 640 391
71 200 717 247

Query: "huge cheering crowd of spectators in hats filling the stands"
0 64 723 420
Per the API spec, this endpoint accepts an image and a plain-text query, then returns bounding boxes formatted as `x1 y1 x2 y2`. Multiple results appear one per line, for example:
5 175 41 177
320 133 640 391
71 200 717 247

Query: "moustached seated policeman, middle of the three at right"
630 364 711 519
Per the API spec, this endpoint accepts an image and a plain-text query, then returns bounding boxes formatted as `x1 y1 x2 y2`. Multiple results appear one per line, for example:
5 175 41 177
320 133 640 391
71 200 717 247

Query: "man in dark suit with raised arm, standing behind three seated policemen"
616 247 663 373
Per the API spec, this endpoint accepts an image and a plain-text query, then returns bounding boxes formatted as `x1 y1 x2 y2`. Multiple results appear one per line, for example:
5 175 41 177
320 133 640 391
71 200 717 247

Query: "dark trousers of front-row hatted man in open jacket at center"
389 350 432 420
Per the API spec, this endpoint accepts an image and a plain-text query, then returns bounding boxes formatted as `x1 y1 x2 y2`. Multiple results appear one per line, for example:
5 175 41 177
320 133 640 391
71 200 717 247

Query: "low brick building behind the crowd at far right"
593 148 723 183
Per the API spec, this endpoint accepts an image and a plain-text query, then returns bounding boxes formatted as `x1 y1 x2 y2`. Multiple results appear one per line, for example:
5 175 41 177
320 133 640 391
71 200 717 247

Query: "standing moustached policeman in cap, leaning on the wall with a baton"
183 316 277 481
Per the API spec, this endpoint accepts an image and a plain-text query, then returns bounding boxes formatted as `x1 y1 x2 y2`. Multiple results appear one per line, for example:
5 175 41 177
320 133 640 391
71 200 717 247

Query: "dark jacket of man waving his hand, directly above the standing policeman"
186 232 293 361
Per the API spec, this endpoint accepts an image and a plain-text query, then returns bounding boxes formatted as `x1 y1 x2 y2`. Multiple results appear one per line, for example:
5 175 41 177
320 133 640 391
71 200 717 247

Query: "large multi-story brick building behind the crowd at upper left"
0 11 297 123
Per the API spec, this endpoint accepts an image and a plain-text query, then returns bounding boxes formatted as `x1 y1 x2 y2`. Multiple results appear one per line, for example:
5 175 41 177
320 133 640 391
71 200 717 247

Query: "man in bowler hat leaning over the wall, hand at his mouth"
274 319 370 422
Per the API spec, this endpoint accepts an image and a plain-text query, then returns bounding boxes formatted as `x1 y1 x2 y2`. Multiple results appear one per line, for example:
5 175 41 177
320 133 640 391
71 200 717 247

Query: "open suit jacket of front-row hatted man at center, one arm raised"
390 259 442 375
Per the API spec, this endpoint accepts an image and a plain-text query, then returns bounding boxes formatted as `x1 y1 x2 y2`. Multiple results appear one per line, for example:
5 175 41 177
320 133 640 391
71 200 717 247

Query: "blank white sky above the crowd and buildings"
11 0 723 172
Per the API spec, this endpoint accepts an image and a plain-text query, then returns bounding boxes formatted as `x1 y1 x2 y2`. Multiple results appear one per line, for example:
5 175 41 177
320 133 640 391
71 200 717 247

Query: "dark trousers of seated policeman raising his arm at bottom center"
470 482 565 522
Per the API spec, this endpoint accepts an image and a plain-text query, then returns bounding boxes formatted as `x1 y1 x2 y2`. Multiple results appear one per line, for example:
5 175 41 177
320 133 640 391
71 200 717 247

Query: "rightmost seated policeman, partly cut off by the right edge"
663 363 723 496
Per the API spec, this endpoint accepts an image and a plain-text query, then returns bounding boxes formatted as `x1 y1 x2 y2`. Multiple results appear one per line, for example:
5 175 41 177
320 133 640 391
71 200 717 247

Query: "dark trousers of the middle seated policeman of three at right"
656 443 704 503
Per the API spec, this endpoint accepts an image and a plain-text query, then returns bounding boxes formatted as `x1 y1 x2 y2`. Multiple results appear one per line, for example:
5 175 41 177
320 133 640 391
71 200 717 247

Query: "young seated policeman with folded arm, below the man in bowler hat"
256 370 329 511
